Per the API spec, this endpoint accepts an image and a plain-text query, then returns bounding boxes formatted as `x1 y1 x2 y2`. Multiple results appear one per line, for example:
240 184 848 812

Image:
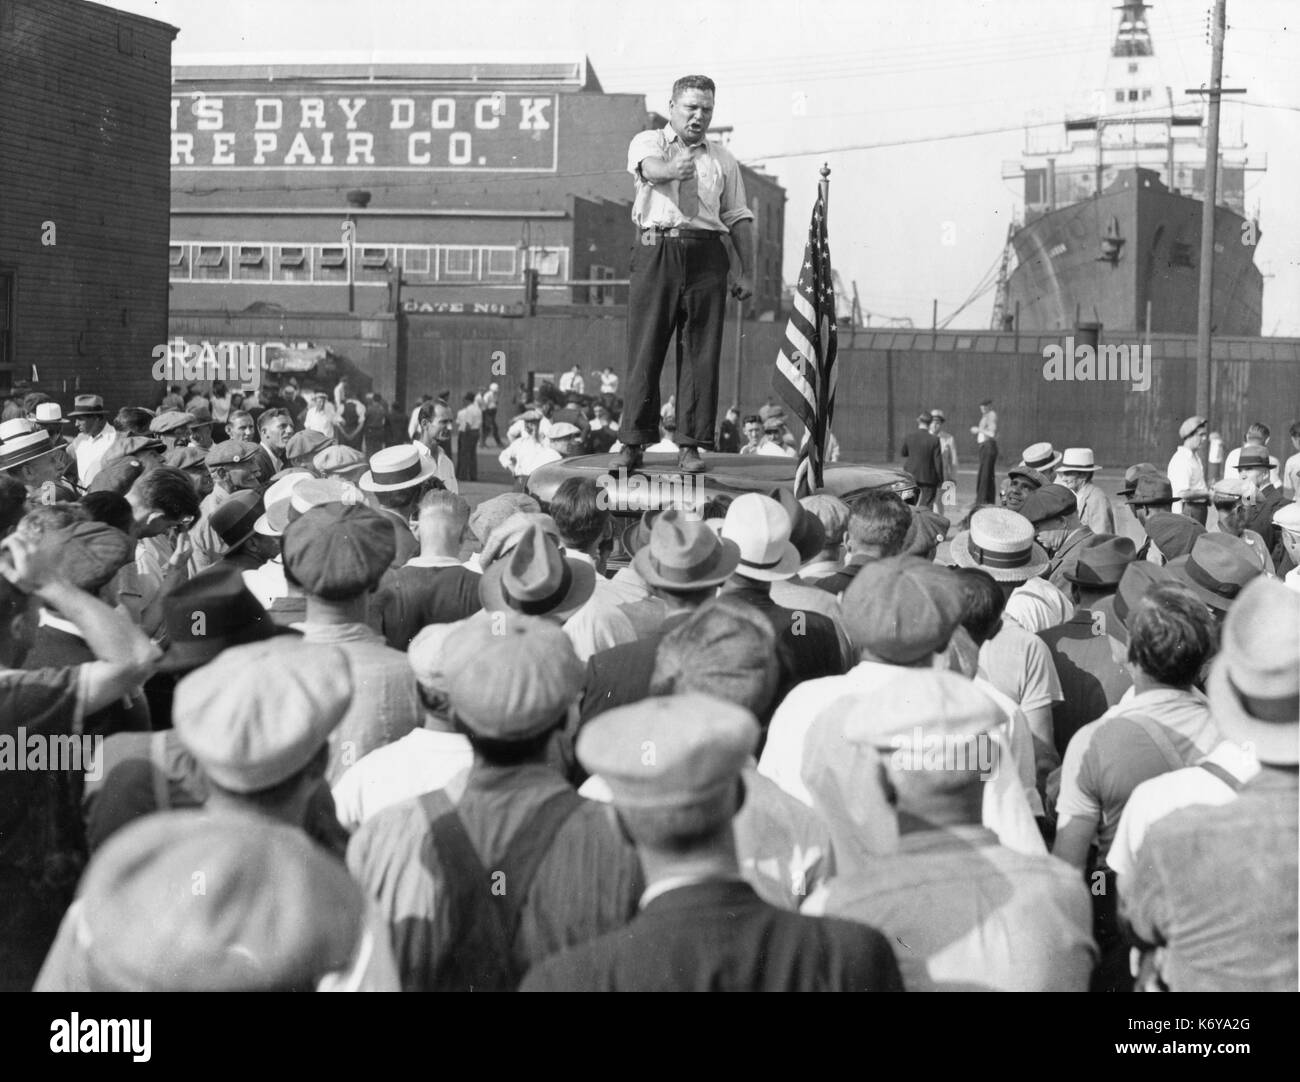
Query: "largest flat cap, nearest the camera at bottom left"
72 812 365 992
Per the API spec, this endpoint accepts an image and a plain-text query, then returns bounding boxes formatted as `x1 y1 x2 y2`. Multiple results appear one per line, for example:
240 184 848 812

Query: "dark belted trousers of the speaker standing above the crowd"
619 233 729 449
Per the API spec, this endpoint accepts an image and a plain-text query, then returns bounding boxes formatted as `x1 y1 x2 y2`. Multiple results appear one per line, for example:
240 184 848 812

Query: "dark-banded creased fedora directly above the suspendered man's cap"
478 523 595 619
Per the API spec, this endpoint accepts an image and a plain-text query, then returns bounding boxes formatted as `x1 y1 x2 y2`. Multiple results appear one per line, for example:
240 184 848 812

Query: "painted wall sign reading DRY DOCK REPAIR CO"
172 87 559 173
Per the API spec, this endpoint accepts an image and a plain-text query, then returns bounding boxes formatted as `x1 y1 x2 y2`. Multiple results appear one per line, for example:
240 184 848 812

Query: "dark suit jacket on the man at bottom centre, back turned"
520 880 902 992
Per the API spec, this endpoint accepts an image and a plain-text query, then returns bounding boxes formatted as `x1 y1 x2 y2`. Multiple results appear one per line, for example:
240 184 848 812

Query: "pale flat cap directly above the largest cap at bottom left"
172 636 355 793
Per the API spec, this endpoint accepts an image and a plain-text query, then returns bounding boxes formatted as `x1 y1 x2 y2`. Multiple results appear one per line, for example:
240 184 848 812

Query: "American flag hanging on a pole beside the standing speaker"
772 191 836 497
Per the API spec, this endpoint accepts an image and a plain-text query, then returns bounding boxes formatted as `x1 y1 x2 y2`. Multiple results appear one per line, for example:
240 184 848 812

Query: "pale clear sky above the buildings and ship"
109 0 1300 336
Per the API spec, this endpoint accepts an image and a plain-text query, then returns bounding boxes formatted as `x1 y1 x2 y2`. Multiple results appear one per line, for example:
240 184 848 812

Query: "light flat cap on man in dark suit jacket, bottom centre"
576 693 759 815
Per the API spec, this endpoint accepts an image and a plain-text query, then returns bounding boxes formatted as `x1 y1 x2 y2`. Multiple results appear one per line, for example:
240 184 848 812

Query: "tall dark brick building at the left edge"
0 0 176 403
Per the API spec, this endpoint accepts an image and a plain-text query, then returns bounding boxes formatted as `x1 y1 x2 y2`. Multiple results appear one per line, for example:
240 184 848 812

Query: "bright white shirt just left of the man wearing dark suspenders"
333 728 475 831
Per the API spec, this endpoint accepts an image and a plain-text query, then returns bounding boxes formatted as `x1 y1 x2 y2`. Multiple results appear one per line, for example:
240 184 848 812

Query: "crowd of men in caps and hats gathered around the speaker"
0 373 1300 991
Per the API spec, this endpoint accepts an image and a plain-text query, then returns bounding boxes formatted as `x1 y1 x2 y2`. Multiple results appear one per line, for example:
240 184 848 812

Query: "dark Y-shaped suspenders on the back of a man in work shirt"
420 789 582 991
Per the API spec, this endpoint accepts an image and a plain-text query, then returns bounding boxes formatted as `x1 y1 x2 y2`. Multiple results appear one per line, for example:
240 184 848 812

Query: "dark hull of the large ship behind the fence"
1006 169 1264 336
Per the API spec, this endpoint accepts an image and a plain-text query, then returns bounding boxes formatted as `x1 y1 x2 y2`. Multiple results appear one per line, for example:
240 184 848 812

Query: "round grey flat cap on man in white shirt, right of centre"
841 555 962 665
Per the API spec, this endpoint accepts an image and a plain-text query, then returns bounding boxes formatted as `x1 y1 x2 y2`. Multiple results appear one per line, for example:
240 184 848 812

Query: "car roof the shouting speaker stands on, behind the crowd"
528 454 917 567
